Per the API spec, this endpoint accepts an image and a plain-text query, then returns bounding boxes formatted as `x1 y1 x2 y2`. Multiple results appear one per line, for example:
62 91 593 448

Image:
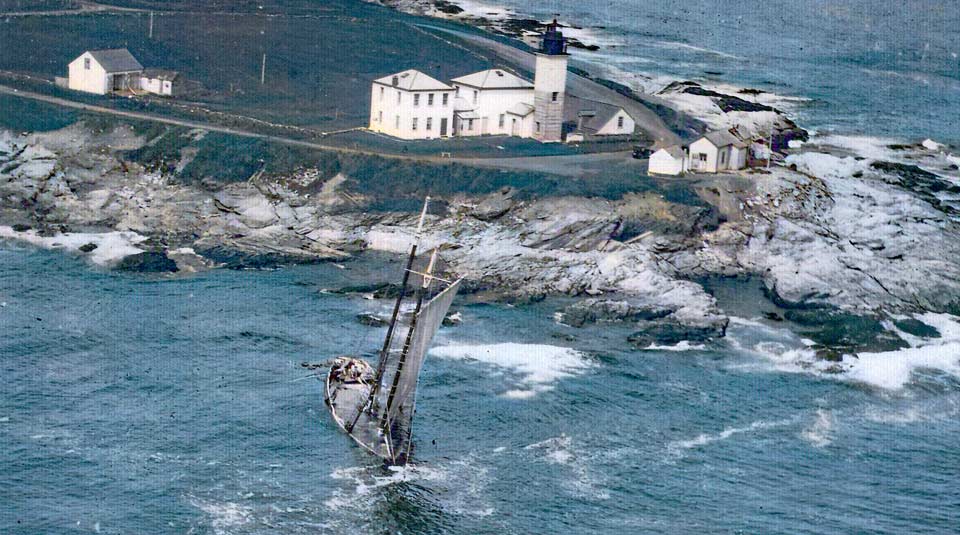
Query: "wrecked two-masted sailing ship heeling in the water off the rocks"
318 197 462 465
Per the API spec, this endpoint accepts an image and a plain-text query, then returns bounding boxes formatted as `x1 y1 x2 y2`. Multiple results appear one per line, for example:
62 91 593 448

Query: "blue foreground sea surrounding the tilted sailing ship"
0 243 960 534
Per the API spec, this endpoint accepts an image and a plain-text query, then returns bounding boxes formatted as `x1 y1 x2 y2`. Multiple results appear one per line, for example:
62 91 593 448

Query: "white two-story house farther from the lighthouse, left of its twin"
370 69 455 139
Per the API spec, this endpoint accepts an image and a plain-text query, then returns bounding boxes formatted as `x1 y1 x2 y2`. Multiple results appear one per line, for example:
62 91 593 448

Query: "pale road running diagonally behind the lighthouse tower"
418 24 680 145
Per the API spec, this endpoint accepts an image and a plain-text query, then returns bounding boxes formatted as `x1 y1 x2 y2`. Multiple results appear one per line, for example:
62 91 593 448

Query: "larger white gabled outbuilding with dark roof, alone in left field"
67 48 143 95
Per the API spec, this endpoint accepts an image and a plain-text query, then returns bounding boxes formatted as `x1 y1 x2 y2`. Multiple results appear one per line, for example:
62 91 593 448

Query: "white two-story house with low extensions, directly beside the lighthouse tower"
450 69 534 137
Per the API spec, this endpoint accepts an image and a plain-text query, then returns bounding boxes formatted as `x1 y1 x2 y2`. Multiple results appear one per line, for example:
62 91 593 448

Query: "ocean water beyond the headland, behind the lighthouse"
472 0 960 144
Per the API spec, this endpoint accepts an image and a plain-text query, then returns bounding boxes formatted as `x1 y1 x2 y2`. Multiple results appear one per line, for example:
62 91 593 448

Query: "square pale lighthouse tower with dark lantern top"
533 19 570 143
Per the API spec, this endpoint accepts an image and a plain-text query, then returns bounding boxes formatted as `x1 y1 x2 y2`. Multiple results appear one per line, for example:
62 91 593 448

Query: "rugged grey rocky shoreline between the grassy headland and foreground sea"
0 110 960 347
